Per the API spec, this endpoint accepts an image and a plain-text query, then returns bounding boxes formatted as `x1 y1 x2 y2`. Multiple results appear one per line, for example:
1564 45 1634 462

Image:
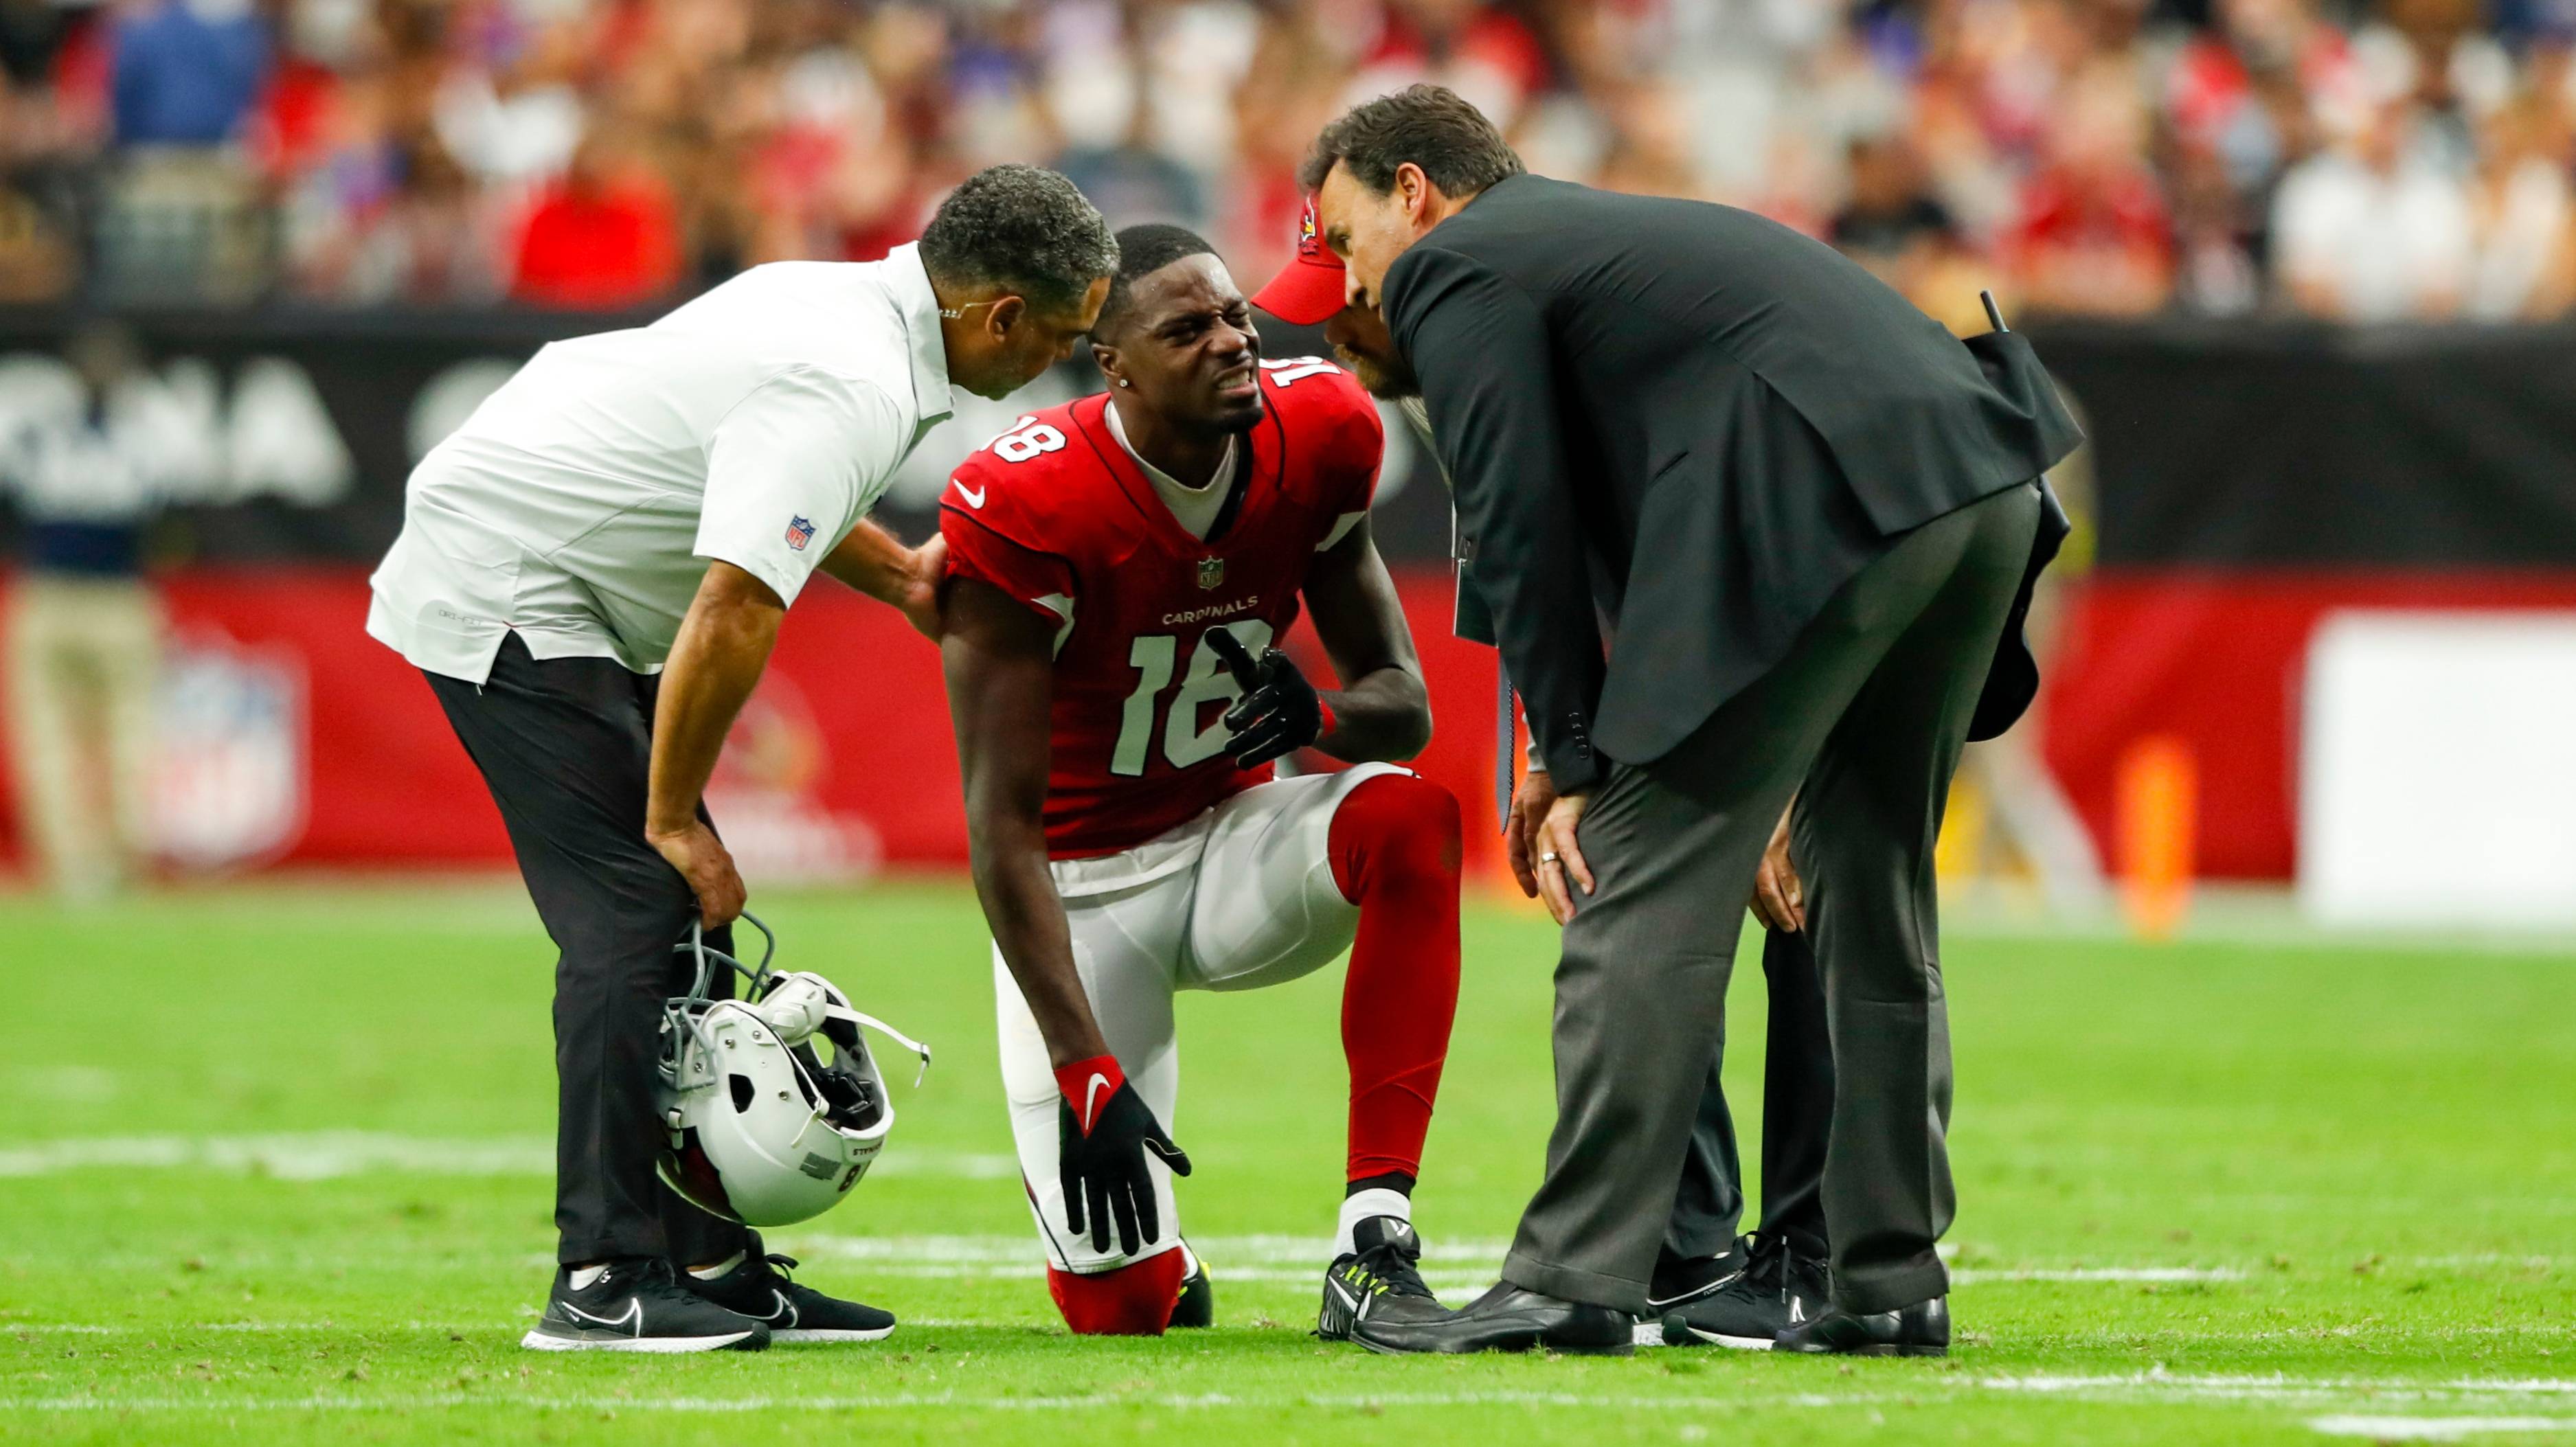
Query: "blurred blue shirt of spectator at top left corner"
113 0 268 147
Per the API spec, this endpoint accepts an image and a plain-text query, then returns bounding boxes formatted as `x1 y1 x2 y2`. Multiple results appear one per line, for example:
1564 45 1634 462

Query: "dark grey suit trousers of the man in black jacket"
1502 484 2040 1313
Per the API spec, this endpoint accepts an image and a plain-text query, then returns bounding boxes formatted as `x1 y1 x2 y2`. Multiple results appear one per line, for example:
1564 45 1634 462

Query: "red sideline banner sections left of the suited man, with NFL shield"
0 567 1500 883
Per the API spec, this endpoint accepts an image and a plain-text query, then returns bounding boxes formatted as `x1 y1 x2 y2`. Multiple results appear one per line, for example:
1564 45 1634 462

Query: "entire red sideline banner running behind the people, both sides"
20 564 2576 880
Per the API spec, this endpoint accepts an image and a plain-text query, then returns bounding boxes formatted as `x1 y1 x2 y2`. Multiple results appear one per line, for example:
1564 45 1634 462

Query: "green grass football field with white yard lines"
0 883 2576 1444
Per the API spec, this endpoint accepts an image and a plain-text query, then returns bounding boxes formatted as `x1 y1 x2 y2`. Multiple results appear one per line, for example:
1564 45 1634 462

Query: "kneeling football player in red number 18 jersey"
940 227 1458 1339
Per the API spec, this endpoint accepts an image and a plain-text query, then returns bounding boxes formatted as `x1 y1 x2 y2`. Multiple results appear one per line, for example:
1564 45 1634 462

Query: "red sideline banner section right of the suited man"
2040 567 2576 880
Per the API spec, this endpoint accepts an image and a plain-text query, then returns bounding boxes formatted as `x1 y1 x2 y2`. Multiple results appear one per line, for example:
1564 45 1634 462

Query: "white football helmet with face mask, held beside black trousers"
662 914 930 1226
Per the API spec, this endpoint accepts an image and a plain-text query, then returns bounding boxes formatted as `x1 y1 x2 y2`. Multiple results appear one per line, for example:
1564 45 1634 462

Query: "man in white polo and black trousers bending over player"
366 165 1118 1352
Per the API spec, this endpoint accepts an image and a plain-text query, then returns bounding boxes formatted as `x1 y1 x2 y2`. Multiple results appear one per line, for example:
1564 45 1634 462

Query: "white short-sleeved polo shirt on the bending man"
366 247 951 683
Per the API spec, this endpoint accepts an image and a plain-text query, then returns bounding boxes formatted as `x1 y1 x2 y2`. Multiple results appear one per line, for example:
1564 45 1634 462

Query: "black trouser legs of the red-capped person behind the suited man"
1656 929 1834 1275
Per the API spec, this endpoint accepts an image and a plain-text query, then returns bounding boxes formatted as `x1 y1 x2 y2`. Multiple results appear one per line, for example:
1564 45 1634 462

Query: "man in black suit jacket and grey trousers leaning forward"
1306 85 2079 1354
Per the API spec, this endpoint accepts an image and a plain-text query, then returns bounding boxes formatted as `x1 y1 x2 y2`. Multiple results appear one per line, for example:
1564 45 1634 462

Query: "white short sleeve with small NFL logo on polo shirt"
696 368 912 602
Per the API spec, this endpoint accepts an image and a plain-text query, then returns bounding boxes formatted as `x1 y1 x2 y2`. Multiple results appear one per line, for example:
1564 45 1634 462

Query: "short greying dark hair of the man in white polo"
923 165 1118 312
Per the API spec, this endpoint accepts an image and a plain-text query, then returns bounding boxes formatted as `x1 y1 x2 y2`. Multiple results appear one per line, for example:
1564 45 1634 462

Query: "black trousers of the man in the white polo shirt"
425 633 752 1267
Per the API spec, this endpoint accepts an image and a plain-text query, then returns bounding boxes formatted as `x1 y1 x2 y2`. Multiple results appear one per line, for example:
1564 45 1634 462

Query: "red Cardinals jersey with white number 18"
940 358 1386 860
